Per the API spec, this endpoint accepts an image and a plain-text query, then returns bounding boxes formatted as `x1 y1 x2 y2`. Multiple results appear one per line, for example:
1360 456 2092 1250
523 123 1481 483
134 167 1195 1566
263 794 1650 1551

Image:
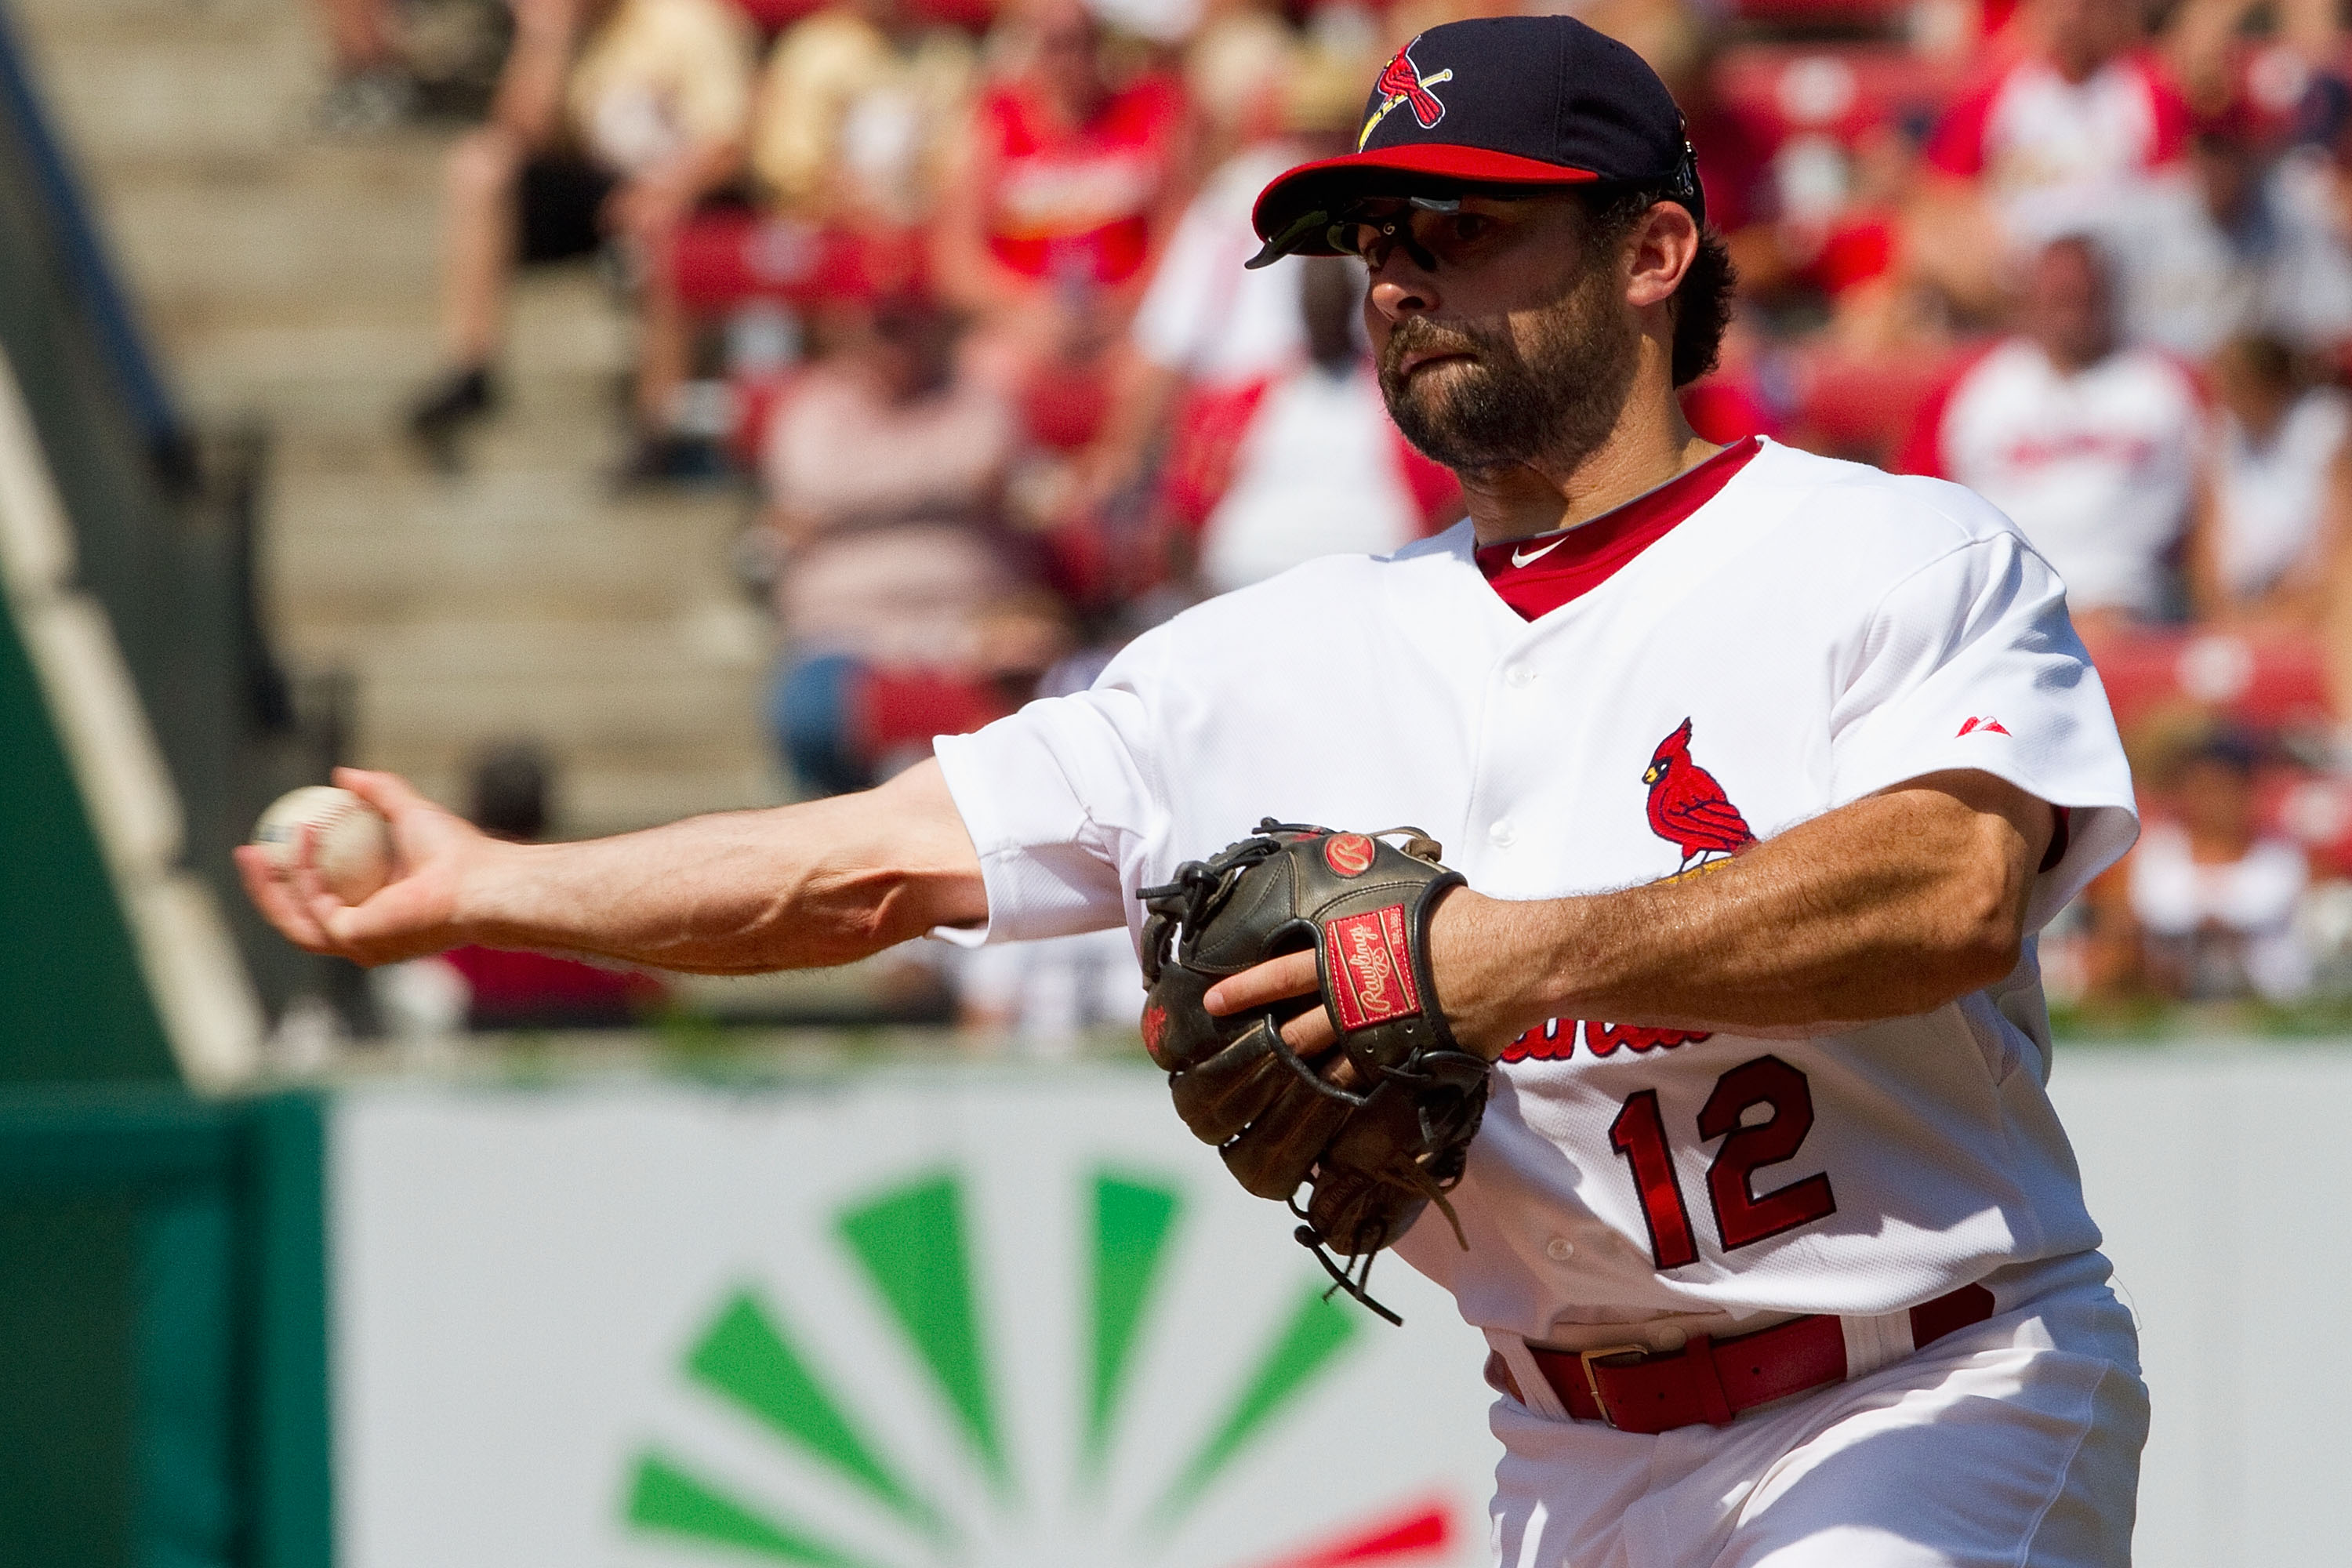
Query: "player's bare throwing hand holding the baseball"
238 769 508 964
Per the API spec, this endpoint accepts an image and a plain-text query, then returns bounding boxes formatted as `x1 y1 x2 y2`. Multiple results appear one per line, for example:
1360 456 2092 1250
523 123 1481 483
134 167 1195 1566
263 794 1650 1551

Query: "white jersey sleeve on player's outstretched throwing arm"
934 640 1167 947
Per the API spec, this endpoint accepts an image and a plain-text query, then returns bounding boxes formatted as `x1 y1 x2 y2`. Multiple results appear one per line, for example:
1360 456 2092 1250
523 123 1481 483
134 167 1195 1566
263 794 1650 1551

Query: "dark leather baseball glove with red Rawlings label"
1141 818 1486 1323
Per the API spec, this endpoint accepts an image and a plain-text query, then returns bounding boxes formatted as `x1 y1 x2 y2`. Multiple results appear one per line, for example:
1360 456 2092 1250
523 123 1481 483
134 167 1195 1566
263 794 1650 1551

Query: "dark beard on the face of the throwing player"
1381 268 1639 473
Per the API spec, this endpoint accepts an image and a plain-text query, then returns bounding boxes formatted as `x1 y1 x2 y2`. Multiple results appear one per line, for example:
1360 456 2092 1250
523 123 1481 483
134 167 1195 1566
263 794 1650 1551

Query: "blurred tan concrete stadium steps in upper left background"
12 0 786 884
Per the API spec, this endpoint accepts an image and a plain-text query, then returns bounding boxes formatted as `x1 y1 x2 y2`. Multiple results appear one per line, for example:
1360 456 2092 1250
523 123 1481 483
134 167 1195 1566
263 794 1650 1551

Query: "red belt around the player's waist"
1486 1286 1992 1434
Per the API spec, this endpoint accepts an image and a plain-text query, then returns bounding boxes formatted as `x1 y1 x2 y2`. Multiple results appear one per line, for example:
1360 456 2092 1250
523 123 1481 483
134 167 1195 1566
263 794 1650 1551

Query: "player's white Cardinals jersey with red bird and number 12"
938 442 2136 1340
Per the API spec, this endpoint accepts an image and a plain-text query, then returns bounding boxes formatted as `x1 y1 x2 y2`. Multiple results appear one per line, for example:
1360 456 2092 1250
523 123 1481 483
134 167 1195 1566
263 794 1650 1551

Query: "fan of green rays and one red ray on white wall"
626 1171 1451 1568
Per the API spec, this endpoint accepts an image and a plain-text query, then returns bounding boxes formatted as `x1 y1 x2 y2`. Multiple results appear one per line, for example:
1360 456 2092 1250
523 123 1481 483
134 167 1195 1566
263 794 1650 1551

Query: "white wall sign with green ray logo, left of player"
329 1065 1496 1568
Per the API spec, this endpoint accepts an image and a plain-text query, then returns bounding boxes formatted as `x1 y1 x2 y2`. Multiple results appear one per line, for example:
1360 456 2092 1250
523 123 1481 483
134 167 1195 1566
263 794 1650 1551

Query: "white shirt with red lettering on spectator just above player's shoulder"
1936 339 2204 616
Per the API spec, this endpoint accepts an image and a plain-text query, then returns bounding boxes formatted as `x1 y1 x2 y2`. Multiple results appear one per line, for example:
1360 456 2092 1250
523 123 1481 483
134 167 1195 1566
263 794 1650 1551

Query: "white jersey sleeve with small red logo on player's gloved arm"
1830 529 2140 931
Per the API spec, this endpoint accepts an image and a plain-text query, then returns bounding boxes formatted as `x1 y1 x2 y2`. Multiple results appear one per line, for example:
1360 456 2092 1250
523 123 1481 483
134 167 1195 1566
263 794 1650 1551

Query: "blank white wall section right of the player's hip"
2051 1041 2352 1568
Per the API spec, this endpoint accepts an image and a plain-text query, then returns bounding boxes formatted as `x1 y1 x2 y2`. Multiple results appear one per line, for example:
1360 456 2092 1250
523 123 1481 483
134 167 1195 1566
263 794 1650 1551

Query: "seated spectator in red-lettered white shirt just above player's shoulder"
1905 238 2201 652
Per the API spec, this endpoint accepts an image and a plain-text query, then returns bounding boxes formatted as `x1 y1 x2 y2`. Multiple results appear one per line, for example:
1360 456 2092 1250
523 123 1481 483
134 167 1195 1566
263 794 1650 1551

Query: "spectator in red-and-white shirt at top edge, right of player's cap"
1915 0 2190 310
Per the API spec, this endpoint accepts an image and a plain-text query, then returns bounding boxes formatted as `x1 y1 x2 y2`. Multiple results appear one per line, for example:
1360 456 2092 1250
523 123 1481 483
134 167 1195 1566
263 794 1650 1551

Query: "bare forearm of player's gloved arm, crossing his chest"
1446 776 2049 1039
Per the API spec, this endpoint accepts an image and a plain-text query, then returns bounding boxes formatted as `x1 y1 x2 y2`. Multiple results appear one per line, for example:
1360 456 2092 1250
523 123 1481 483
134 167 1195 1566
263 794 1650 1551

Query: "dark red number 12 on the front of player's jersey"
1609 1055 1837 1269
